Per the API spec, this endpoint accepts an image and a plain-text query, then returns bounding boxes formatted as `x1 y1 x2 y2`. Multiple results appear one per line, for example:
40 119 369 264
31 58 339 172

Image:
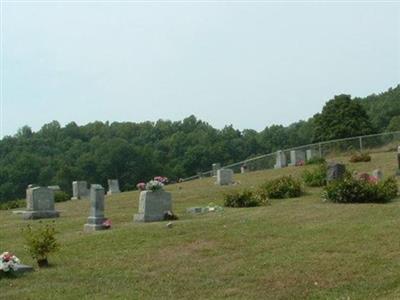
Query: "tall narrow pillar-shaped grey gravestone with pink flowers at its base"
84 184 107 231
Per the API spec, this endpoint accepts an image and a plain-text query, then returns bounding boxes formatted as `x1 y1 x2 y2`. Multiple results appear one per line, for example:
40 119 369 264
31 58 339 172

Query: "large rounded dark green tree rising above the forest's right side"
314 95 373 141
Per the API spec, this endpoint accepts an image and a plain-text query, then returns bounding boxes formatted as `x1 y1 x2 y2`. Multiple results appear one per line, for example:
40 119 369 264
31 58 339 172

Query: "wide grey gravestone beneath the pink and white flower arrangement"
133 190 172 222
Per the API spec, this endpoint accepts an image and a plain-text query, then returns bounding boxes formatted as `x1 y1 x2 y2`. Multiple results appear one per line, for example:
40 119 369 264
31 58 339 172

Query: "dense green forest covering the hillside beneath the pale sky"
0 85 400 202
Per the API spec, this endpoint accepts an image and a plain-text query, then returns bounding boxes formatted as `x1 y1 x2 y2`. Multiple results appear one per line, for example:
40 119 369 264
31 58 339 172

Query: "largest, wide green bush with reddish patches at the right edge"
323 175 398 203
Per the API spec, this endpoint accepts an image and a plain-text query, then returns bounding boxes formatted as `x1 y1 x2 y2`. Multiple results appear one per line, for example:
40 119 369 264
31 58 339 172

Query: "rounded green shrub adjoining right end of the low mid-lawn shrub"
261 176 303 199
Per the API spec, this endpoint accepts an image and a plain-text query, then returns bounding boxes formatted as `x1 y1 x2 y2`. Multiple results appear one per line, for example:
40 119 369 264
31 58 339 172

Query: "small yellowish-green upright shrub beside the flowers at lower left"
22 224 59 267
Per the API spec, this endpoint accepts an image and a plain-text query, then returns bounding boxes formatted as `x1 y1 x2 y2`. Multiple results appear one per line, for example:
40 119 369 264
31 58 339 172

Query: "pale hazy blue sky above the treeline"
0 0 400 136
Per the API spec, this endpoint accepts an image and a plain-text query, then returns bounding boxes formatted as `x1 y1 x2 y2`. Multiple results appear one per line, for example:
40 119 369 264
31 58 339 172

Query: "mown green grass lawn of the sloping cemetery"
0 152 400 299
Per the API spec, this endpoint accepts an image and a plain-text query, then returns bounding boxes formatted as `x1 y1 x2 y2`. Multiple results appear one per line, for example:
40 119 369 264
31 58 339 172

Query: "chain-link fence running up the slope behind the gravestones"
182 131 400 182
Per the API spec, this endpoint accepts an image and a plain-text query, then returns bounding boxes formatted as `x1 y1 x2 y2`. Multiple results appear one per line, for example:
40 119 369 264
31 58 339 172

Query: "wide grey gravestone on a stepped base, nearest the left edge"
22 187 60 220
